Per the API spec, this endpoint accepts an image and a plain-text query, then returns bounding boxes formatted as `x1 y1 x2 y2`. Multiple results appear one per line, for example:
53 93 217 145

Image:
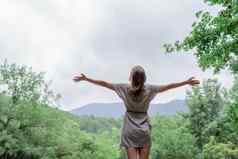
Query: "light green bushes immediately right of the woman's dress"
152 115 199 159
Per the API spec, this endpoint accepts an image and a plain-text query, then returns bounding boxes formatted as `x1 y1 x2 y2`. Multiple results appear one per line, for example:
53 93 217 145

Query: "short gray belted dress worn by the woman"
113 83 160 148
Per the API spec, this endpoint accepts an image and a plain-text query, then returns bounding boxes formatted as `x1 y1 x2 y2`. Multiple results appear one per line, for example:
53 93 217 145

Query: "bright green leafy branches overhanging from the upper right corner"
165 0 238 73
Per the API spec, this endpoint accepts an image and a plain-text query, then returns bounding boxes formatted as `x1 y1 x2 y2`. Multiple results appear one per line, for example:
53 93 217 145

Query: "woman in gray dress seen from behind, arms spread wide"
74 66 199 159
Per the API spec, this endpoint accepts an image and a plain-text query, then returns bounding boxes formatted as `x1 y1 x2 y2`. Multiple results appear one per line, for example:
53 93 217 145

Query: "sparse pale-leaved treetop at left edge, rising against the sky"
0 60 60 106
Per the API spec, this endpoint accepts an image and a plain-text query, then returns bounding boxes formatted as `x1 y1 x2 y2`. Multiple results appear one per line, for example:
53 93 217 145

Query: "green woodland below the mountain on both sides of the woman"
0 62 238 159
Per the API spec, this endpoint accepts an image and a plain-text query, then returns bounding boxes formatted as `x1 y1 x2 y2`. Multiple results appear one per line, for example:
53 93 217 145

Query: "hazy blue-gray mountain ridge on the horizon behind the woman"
71 100 188 118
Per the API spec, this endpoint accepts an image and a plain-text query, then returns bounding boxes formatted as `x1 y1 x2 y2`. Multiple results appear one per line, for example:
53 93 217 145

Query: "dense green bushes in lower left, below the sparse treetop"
0 94 97 159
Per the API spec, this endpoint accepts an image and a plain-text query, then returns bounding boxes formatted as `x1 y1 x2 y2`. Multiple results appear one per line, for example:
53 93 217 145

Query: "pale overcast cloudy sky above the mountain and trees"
0 0 232 110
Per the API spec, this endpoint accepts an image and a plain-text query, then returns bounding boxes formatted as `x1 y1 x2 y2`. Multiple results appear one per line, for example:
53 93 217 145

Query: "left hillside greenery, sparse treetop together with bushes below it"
0 61 115 159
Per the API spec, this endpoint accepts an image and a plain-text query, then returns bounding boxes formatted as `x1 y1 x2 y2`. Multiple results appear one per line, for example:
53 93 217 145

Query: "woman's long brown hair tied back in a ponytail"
129 65 146 95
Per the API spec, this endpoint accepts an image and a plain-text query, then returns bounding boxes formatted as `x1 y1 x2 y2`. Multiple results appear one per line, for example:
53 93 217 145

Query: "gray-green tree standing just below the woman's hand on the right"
187 79 224 149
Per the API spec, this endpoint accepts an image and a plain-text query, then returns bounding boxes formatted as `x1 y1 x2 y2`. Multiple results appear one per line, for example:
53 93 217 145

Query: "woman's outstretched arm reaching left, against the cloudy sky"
73 74 114 90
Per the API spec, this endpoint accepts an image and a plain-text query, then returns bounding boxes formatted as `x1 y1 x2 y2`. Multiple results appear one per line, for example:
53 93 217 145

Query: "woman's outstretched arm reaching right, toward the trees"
159 77 200 92
